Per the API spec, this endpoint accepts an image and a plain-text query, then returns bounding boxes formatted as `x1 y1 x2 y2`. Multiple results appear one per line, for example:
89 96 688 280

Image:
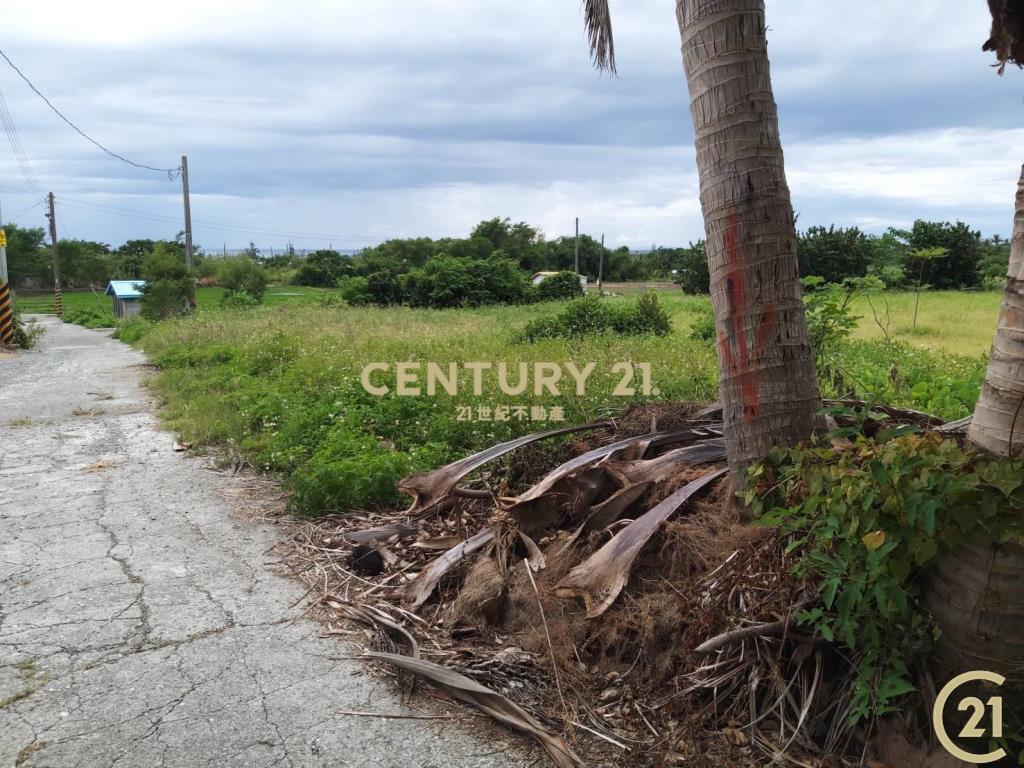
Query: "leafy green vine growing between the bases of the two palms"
745 432 1024 720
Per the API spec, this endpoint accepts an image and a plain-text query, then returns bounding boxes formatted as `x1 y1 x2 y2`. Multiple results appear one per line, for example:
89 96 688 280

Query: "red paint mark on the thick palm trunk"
718 214 775 421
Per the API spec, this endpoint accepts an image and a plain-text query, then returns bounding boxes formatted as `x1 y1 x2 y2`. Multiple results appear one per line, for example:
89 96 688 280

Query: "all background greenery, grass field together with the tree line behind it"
14 214 1008 514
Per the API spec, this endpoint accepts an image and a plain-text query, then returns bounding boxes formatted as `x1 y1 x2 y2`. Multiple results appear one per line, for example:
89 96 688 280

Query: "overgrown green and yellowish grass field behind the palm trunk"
105 288 999 514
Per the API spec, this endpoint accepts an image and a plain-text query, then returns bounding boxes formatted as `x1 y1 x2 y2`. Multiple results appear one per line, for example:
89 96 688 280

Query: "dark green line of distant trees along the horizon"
4 218 1010 306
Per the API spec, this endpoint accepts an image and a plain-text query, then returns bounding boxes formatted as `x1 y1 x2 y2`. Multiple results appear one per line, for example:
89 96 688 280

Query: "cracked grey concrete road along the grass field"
0 318 526 768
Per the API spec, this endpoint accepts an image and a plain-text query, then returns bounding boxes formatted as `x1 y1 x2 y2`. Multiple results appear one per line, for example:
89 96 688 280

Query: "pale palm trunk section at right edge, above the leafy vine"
968 165 1024 457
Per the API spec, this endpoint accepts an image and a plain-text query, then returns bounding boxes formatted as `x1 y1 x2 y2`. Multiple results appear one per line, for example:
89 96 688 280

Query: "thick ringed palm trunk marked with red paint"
676 0 819 486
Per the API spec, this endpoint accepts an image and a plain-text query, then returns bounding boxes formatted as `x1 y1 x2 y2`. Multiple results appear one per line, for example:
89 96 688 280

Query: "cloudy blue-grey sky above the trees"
0 0 1024 249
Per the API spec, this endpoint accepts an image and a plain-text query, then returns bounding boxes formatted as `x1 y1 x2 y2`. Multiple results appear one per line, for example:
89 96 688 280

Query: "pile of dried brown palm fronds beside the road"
282 403 946 767
